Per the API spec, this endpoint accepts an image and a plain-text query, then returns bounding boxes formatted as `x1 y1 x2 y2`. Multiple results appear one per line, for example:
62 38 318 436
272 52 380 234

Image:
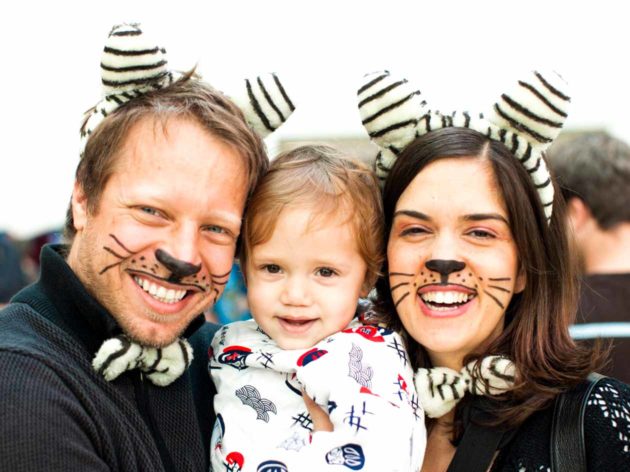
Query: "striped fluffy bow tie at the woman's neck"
414 356 516 418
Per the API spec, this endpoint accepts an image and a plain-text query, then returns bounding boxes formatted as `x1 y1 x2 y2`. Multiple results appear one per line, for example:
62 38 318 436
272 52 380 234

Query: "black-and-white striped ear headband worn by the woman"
358 71 570 219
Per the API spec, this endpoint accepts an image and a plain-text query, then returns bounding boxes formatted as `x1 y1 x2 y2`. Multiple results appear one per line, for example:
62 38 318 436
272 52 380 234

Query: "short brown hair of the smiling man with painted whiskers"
64 71 269 242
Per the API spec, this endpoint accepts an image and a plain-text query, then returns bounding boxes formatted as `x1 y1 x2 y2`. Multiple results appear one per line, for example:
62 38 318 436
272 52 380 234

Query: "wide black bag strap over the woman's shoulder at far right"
550 372 606 472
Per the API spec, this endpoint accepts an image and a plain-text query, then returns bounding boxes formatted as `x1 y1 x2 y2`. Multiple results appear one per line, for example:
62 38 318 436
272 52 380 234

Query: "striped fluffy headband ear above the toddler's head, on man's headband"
230 73 295 138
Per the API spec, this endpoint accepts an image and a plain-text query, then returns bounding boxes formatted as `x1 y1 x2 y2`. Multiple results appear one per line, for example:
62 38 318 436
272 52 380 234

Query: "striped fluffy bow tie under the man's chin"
92 335 193 387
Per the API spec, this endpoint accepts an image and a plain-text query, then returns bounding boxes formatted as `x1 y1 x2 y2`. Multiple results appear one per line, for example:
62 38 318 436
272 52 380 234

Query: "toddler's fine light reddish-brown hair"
240 145 384 291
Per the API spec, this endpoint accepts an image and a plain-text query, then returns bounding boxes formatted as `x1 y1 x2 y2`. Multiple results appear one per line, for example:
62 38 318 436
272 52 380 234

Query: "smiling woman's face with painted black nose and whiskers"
387 157 525 369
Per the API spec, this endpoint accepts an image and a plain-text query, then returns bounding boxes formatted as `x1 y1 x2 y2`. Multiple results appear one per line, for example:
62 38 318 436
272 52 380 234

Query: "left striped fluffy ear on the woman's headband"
357 71 427 155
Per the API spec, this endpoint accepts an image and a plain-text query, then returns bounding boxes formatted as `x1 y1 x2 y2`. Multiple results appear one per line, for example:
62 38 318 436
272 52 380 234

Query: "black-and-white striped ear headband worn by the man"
80 23 295 157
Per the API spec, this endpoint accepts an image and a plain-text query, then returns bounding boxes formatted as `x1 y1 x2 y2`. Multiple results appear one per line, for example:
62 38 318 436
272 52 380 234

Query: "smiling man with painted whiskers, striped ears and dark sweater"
0 25 290 471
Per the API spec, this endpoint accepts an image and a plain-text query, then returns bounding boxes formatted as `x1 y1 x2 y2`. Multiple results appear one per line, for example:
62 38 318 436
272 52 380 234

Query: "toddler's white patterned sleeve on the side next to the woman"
287 325 426 472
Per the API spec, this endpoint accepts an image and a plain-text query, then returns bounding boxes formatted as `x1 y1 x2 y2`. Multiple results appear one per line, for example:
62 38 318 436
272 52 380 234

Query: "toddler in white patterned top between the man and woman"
209 146 426 472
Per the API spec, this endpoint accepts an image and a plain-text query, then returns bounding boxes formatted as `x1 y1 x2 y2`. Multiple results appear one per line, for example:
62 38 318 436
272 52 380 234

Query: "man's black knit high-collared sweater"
0 246 216 472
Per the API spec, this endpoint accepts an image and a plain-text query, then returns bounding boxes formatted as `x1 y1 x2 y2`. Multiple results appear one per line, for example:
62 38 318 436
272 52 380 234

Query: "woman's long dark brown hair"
376 128 603 430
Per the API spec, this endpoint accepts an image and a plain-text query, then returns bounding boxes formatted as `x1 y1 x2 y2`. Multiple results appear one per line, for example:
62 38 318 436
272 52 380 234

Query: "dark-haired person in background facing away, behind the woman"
549 132 630 383
